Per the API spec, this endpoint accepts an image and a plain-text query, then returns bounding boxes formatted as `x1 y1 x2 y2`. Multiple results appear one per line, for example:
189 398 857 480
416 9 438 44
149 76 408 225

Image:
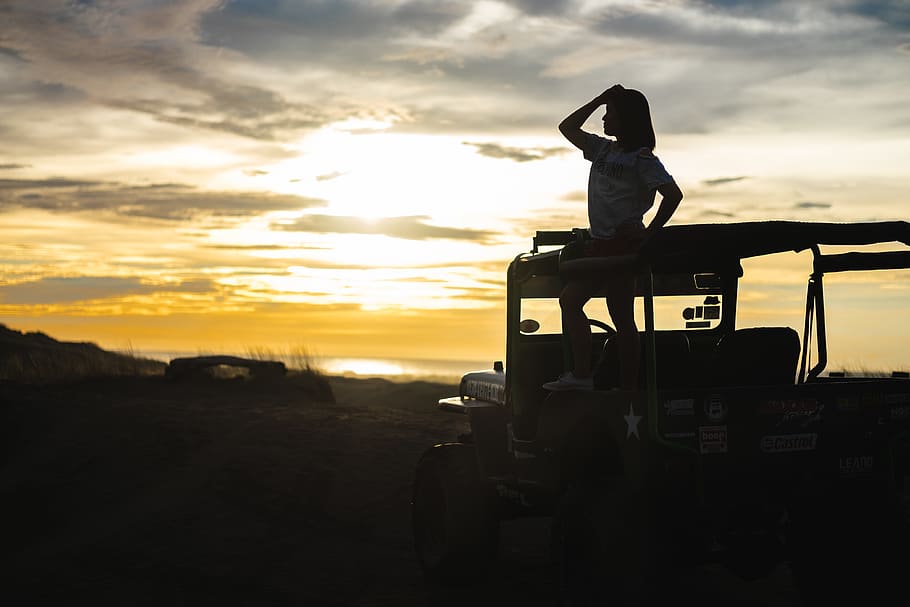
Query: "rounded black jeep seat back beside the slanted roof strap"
710 327 800 386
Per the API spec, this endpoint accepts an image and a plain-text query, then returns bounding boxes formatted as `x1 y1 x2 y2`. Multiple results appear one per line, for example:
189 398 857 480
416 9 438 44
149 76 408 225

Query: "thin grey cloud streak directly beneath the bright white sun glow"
271 214 494 242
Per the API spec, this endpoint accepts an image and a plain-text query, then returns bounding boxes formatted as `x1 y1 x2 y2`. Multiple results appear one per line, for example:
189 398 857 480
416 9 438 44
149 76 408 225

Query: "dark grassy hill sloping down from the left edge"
0 324 167 382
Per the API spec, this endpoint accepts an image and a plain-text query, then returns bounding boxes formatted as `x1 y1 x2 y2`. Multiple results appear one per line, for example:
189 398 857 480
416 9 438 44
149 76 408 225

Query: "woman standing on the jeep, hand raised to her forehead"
543 84 683 390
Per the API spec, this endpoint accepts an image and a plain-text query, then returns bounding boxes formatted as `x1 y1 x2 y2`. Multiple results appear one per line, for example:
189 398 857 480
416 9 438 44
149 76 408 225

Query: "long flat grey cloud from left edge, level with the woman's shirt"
0 178 326 221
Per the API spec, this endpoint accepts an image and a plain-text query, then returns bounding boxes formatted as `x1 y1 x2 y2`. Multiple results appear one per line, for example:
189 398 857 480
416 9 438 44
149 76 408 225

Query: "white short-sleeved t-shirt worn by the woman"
584 133 673 238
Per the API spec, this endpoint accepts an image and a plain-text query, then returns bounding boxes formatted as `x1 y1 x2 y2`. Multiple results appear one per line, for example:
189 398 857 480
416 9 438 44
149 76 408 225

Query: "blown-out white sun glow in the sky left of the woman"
263 130 576 227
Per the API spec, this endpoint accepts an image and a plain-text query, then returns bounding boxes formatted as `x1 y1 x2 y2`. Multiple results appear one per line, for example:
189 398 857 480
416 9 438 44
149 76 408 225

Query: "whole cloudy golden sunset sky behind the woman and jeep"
0 0 910 364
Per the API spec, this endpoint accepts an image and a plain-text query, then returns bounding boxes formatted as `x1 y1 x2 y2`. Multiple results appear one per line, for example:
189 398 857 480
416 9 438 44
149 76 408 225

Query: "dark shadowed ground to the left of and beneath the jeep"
0 378 797 607
